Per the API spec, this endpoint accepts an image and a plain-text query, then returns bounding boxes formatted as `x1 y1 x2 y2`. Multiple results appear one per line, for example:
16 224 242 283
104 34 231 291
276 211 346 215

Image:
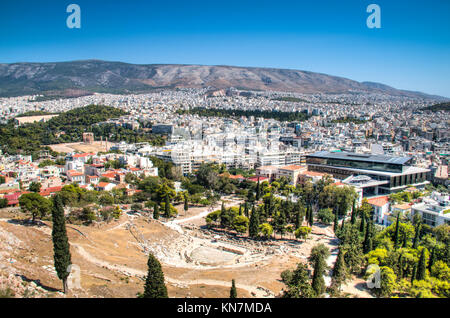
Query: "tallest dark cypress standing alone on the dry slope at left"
52 194 72 293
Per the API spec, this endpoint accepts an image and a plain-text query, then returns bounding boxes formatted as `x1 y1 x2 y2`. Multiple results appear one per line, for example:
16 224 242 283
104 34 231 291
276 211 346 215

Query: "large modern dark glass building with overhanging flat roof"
306 151 430 194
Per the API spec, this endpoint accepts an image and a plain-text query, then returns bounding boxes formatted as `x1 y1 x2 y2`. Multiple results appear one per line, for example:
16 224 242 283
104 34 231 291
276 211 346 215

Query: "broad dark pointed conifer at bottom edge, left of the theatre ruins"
143 253 168 298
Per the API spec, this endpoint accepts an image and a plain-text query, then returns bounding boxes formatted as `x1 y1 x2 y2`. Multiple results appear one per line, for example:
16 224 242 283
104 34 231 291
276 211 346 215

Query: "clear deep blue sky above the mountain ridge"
0 0 450 97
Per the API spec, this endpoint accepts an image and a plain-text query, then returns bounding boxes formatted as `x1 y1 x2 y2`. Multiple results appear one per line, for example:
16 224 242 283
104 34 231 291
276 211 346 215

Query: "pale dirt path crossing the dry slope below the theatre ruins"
71 243 273 298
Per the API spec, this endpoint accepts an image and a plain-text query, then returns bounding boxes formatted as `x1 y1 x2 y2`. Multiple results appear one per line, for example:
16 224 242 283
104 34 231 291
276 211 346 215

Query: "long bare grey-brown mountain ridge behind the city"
0 60 446 100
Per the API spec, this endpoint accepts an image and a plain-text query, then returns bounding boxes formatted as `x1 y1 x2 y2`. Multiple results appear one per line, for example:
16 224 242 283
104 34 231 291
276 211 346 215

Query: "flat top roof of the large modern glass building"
306 151 412 165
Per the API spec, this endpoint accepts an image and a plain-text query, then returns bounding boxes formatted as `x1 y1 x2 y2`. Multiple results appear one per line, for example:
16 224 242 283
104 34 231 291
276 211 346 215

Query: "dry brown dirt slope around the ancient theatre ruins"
0 201 370 297
